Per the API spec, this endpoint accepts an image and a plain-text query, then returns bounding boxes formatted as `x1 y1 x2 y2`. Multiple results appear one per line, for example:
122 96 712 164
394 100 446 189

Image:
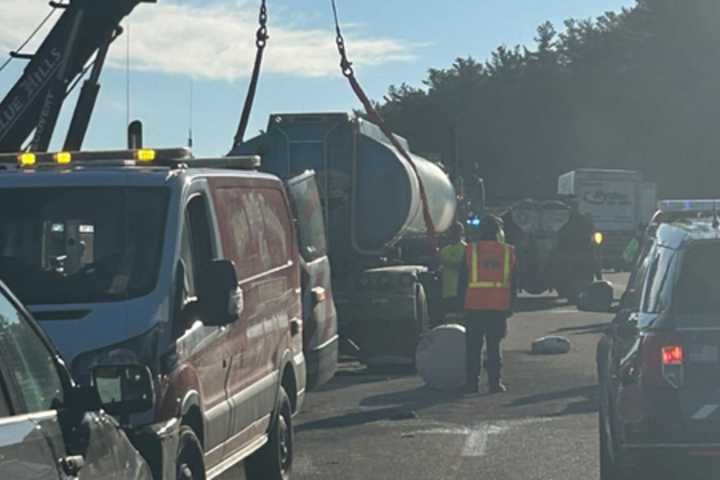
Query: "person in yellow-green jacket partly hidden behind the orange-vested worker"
440 222 467 320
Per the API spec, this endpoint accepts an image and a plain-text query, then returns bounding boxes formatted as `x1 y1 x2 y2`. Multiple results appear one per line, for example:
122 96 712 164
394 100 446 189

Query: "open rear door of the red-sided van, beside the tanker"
288 172 337 388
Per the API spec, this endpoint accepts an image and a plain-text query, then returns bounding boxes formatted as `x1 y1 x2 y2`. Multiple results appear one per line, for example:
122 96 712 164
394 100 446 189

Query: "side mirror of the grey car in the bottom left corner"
92 365 155 415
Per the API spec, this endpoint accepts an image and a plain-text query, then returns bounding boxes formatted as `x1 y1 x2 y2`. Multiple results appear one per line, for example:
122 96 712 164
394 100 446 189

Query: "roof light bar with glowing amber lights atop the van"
0 148 261 170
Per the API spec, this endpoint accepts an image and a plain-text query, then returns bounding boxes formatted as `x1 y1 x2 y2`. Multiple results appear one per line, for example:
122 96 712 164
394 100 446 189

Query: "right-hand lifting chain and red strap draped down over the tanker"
330 0 438 248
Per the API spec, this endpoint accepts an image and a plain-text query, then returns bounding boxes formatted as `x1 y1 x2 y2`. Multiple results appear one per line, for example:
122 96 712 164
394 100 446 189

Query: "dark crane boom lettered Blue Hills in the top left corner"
0 0 156 153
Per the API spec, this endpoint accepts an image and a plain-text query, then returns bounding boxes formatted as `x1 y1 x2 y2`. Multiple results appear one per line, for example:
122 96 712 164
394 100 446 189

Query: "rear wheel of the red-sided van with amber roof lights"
247 387 295 480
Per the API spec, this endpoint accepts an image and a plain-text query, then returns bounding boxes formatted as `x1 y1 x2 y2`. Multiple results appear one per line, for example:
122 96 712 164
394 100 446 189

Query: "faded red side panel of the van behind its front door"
210 177 299 454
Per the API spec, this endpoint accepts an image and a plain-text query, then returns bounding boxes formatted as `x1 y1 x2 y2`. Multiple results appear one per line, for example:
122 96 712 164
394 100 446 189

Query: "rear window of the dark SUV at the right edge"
674 242 720 318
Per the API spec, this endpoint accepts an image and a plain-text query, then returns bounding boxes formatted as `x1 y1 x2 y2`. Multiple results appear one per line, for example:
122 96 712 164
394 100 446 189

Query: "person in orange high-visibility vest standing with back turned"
461 216 516 393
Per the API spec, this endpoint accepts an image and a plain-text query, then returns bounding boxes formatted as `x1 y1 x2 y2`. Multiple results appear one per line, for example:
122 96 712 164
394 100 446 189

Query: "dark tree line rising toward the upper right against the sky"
378 0 720 200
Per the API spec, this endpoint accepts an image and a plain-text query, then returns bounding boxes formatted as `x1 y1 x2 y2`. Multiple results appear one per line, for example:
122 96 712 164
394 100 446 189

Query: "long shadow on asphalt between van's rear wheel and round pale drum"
295 387 461 432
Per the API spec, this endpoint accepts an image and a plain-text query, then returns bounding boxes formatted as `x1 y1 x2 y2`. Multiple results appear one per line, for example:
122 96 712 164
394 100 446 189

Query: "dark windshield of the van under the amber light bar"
0 187 168 305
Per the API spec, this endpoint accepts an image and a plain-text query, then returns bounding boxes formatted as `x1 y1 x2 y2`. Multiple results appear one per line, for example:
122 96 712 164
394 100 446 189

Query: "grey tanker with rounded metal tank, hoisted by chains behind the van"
240 113 457 364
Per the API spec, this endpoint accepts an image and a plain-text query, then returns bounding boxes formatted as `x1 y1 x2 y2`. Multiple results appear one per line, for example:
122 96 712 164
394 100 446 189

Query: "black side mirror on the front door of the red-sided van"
199 260 244 327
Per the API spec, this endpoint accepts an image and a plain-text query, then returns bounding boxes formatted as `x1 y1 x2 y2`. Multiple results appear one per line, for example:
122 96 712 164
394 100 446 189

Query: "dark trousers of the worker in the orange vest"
465 310 508 385
